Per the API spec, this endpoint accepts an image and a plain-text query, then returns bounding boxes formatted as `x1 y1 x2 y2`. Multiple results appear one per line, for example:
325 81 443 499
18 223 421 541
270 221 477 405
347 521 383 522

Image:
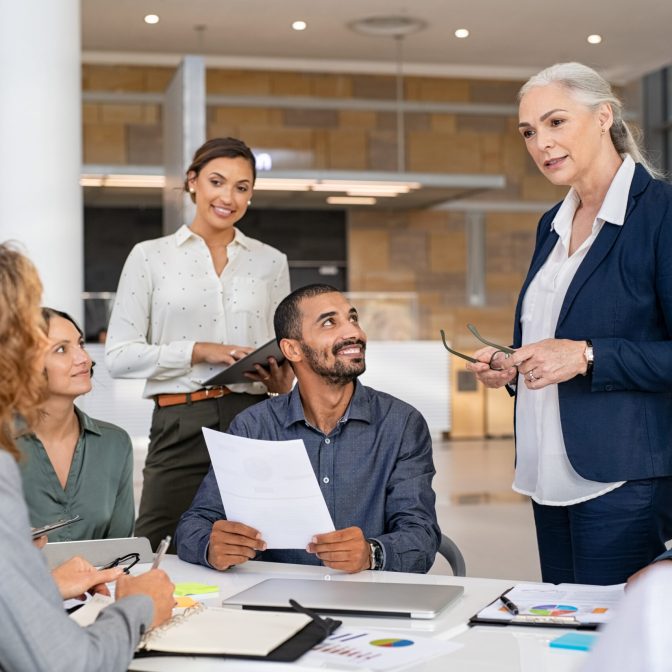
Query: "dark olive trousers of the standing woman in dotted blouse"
135 394 266 552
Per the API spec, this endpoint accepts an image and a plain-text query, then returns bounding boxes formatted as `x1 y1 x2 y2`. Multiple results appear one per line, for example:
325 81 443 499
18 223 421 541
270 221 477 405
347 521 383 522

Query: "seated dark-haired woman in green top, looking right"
17 308 135 541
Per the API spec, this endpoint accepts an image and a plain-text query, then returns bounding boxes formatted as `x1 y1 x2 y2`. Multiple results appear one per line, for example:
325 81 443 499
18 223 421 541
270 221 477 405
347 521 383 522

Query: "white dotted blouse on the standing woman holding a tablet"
105 226 290 397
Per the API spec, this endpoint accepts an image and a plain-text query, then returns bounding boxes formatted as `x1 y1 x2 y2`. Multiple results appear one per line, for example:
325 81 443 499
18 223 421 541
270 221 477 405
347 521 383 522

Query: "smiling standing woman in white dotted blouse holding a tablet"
105 138 293 547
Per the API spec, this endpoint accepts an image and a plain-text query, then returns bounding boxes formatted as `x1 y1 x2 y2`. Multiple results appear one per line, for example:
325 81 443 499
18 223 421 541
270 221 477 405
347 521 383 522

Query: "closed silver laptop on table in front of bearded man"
222 579 464 618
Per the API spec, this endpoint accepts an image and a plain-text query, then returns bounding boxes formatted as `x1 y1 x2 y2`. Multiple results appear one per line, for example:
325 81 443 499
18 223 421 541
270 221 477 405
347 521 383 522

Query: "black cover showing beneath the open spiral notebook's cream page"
134 600 342 663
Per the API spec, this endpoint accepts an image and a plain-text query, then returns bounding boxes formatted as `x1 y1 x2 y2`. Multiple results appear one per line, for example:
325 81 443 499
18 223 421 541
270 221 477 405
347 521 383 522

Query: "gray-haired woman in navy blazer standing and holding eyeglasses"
469 63 672 584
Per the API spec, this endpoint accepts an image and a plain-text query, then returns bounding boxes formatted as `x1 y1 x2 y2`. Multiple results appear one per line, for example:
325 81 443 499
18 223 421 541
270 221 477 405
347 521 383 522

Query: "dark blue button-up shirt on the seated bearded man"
176 382 441 572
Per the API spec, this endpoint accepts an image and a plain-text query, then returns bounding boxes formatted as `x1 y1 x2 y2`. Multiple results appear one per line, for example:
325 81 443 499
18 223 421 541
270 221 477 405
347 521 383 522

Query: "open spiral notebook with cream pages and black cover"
71 595 340 661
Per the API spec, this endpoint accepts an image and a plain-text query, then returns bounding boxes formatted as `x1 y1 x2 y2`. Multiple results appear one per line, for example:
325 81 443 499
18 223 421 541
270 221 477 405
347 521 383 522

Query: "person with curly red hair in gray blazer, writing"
0 244 174 672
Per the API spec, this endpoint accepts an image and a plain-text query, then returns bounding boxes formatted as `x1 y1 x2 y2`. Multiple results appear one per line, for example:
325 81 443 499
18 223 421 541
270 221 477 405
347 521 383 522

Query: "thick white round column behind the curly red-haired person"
0 0 84 324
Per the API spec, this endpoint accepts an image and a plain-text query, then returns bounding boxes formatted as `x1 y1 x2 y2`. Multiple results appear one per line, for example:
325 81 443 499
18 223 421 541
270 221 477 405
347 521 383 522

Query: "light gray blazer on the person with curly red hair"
0 450 153 672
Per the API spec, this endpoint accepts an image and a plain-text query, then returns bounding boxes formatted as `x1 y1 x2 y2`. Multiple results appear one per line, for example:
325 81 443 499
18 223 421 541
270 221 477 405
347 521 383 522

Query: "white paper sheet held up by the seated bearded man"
203 427 335 548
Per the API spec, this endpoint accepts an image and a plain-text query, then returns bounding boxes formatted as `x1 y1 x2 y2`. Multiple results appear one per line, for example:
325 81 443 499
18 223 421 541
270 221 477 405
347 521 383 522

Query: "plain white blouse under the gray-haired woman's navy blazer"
513 155 635 506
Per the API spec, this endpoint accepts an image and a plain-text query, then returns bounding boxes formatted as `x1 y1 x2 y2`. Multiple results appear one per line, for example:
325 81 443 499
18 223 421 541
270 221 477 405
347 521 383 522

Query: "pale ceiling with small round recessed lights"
82 0 672 83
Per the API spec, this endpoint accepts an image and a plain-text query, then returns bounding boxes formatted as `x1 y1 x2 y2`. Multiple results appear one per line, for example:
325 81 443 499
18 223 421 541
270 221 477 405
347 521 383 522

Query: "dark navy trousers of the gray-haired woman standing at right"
532 477 672 585
